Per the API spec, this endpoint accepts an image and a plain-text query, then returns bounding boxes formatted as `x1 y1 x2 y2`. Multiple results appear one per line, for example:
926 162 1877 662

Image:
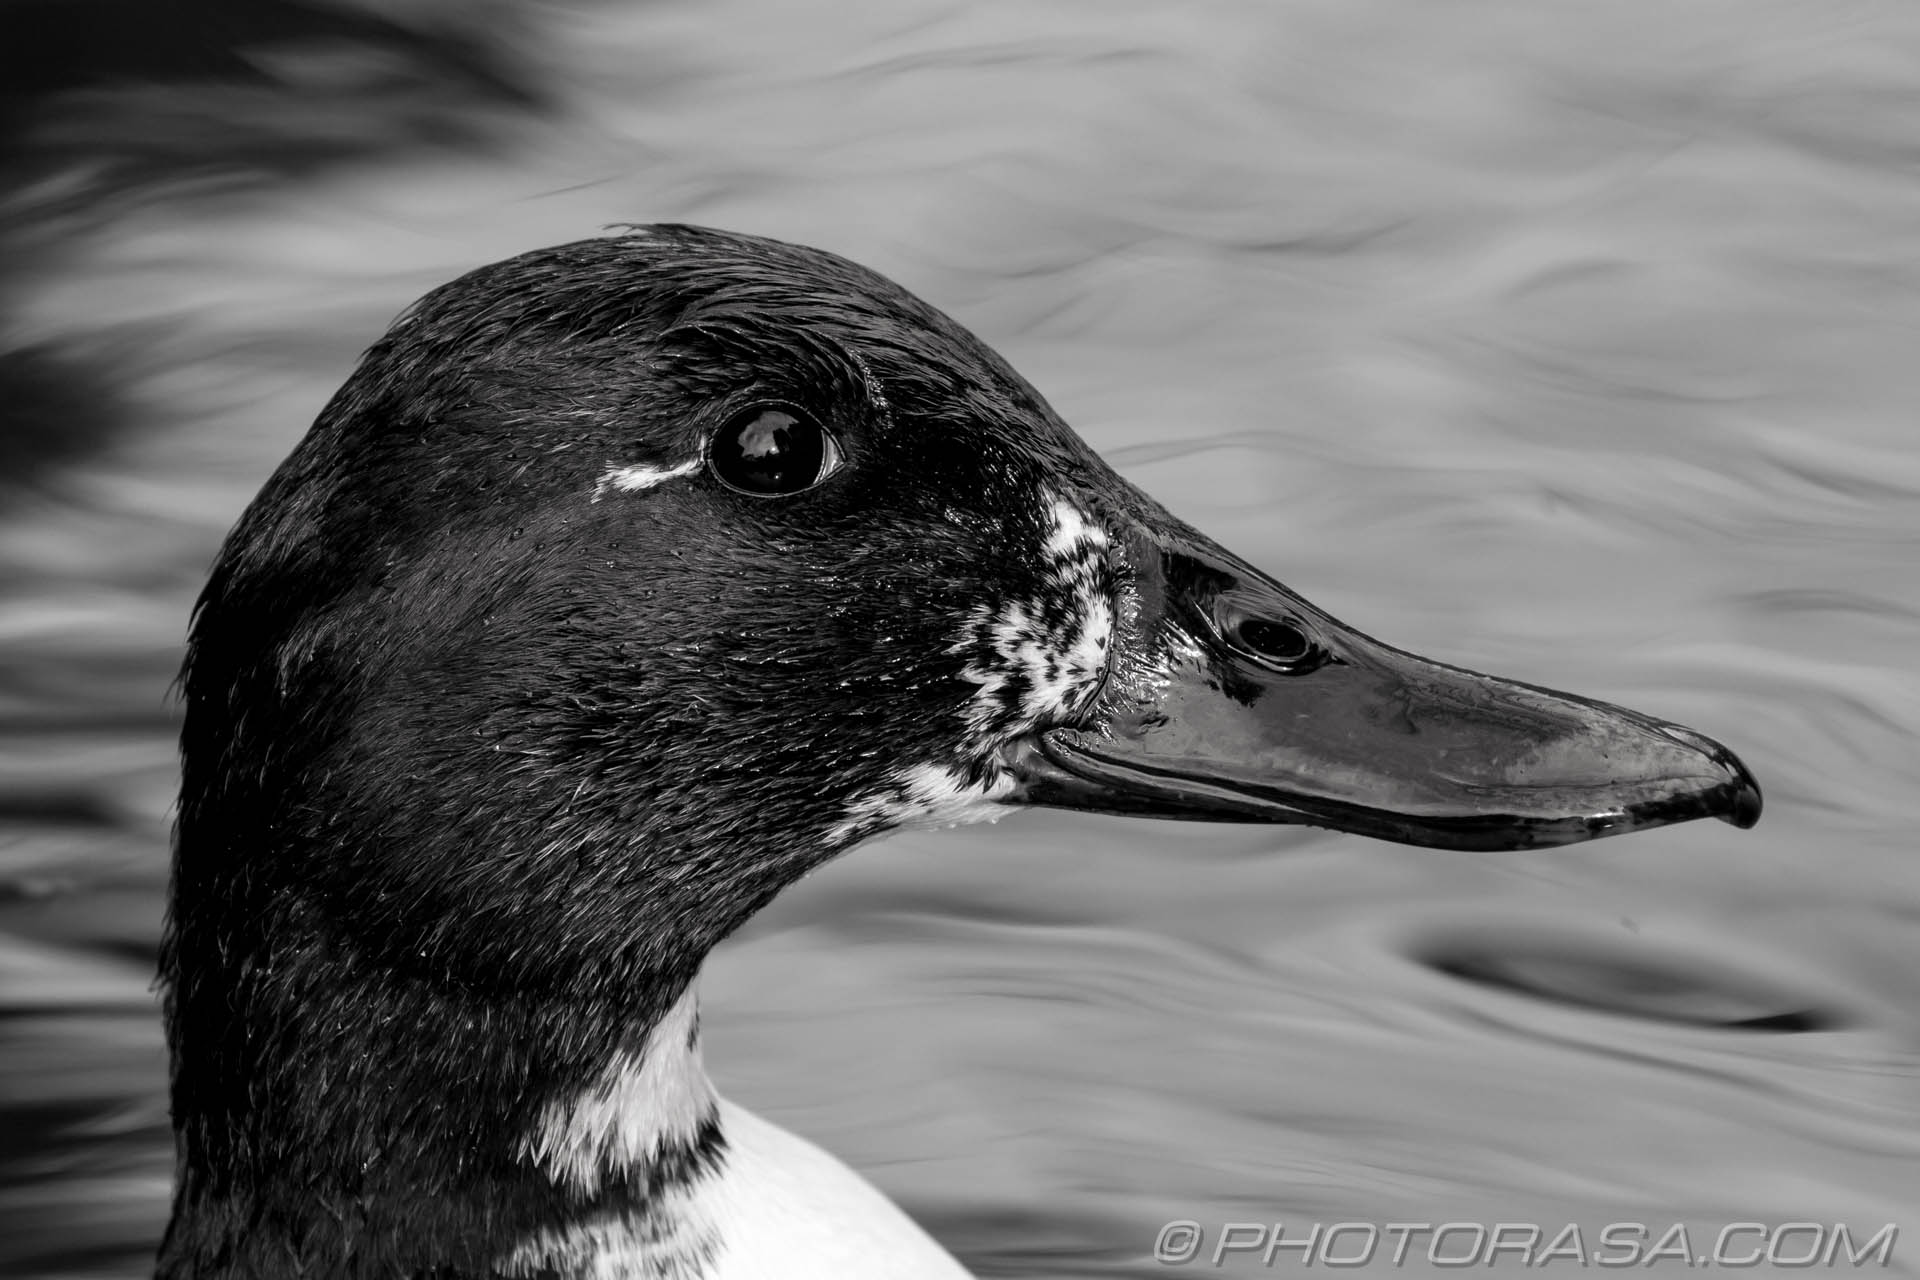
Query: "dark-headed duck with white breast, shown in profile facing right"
156 225 1761 1280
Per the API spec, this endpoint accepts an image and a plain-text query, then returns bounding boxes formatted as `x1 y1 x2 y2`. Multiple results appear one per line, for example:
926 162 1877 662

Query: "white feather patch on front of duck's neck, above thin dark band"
520 986 718 1196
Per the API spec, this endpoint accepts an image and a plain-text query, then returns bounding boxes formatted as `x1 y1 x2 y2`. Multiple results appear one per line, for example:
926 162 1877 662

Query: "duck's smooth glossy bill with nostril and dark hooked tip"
1020 512 1761 850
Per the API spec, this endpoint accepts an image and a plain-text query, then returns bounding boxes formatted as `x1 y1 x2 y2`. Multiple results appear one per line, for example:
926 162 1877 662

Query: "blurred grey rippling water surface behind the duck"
0 0 1920 1278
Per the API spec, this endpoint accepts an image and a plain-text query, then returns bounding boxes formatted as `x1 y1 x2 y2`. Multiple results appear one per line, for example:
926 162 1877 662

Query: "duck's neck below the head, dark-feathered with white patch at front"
157 909 726 1280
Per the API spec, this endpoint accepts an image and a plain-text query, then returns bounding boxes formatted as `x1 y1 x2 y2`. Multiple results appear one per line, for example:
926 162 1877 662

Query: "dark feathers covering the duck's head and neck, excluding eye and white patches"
163 226 1128 1274
